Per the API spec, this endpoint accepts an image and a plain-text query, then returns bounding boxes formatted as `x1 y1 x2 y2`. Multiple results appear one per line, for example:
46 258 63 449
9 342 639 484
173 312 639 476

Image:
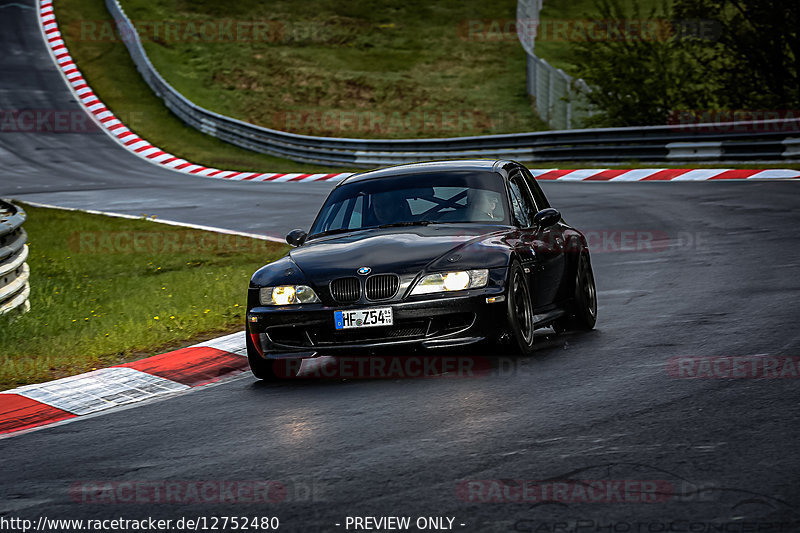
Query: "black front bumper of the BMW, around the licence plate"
247 287 507 359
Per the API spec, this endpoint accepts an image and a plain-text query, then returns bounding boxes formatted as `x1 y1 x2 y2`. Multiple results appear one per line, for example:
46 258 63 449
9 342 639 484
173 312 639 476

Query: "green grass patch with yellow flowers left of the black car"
0 204 288 389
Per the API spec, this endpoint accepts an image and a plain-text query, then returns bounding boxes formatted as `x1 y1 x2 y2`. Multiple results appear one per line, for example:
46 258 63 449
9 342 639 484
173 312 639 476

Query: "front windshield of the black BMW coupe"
310 172 509 237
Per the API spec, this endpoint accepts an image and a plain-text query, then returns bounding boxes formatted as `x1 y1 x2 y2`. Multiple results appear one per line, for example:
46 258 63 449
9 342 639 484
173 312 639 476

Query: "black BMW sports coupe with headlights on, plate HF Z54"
247 161 597 379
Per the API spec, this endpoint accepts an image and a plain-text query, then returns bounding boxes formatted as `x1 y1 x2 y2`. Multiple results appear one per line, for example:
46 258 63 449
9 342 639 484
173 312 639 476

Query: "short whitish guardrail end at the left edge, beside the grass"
0 200 31 315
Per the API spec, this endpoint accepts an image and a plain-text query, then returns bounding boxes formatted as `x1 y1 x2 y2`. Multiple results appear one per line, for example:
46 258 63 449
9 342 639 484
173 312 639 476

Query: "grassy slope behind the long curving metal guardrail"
65 0 545 138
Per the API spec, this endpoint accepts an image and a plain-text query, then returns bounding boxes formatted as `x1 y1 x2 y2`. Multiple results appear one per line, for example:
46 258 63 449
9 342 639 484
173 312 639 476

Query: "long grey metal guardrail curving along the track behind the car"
106 0 800 168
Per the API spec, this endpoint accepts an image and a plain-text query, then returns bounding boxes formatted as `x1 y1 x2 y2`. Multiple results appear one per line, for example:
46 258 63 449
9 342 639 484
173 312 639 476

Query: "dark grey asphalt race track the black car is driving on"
0 0 800 532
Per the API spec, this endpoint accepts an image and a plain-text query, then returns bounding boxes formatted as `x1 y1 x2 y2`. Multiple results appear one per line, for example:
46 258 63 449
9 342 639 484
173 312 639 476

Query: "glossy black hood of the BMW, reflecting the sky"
289 224 509 282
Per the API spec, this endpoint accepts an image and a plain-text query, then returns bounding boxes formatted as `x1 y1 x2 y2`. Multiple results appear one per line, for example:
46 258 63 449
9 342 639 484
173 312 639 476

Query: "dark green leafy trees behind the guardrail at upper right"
573 0 800 126
